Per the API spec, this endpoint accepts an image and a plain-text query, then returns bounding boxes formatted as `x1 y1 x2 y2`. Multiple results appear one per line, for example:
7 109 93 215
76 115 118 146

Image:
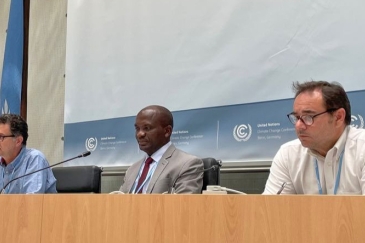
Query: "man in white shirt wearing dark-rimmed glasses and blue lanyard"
264 81 365 195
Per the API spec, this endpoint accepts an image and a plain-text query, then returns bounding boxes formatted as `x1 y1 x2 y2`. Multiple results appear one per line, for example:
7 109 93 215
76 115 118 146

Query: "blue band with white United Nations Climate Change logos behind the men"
65 90 365 166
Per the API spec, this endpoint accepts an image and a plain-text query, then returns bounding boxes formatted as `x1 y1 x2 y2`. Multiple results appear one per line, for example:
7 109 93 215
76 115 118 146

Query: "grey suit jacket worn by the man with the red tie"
120 145 203 193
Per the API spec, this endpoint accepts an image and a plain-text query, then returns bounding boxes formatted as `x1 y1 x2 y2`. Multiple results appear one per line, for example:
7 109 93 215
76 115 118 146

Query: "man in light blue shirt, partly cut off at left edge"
0 114 57 194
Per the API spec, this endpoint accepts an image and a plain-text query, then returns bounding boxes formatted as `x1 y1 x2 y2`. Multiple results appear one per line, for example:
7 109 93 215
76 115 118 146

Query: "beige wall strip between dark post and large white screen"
26 0 67 164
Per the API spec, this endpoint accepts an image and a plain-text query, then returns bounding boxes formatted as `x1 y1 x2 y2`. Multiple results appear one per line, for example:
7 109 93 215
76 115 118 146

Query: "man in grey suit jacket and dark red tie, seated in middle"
120 105 203 193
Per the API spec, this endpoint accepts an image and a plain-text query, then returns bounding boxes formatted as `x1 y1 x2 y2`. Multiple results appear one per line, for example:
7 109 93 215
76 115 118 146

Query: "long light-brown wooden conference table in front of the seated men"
0 194 365 243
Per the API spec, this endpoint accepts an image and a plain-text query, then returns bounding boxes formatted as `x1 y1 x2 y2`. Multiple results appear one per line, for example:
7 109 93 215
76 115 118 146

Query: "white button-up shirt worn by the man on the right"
263 126 365 195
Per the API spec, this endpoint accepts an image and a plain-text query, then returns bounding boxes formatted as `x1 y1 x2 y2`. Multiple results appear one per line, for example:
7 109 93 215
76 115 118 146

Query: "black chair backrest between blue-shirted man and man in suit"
52 165 103 193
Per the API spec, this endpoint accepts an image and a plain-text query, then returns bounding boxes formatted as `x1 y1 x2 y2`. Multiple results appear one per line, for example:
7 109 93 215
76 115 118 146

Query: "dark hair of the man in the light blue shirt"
0 114 28 145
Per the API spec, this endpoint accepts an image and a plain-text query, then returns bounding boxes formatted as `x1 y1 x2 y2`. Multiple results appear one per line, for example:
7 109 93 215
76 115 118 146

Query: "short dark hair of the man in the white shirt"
293 81 351 125
